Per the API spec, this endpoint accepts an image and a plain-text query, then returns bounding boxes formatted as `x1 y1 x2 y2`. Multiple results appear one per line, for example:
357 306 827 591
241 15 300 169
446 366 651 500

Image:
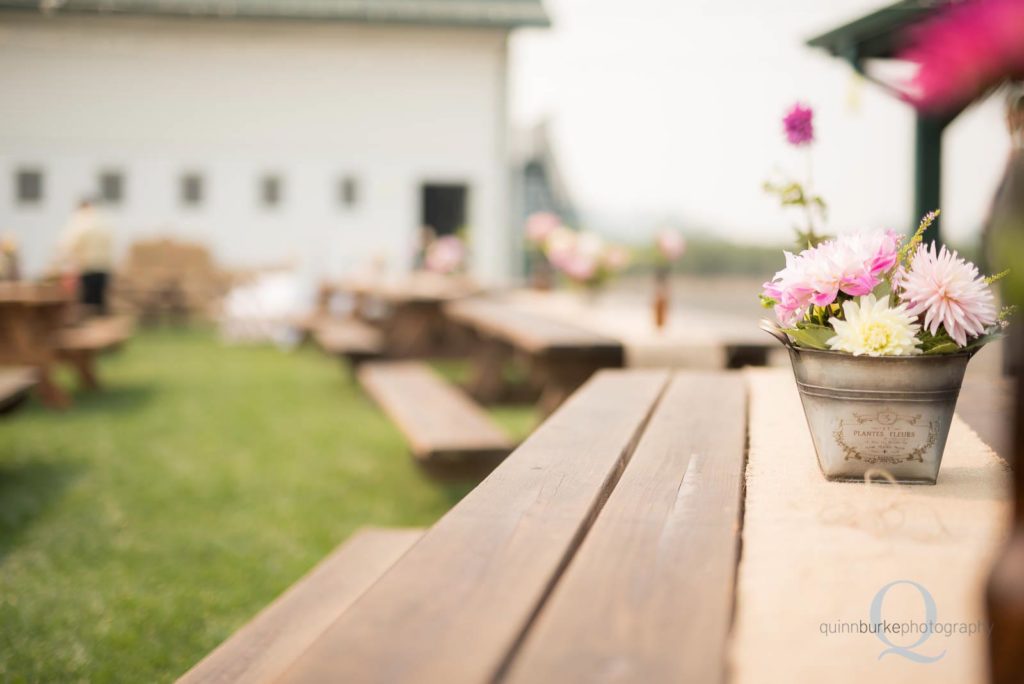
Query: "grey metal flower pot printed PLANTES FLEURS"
786 344 974 484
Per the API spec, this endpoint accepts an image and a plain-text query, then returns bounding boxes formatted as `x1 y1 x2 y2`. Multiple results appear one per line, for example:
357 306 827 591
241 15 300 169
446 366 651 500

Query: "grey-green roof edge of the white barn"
0 0 550 29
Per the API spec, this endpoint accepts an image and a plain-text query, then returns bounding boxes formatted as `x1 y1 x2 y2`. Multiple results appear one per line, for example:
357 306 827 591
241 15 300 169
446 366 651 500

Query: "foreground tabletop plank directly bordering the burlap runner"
508 373 746 683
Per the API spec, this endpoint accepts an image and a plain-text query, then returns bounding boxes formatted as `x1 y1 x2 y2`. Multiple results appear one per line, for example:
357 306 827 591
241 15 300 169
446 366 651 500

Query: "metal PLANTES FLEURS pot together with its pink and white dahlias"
761 211 1011 483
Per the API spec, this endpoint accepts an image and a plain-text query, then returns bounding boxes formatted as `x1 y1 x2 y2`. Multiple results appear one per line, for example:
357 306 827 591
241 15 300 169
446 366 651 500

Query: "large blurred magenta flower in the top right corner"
897 0 1024 111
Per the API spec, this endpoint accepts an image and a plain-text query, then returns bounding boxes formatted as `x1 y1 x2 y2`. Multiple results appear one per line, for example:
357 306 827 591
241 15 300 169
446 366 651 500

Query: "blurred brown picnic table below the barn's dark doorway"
328 271 479 358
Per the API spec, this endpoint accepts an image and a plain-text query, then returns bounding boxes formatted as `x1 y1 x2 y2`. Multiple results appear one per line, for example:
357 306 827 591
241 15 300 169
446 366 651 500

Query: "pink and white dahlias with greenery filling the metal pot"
761 211 1010 356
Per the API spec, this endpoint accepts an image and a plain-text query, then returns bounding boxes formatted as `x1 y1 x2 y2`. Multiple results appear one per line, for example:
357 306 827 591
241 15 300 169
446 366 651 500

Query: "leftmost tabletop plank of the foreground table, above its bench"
282 371 668 684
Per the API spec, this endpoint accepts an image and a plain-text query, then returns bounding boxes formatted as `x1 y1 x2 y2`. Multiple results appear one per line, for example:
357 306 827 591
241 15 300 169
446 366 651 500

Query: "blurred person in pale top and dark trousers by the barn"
58 199 114 315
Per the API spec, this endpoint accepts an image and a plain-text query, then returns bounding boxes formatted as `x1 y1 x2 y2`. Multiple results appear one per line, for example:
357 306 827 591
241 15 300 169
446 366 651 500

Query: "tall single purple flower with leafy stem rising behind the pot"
764 102 827 247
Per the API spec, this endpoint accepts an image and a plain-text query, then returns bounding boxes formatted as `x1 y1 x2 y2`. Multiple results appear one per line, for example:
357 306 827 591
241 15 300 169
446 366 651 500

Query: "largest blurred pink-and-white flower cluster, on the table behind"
543 225 631 288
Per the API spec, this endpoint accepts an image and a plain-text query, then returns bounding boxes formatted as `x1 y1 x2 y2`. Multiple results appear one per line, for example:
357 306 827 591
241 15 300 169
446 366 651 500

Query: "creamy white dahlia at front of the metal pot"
828 295 921 356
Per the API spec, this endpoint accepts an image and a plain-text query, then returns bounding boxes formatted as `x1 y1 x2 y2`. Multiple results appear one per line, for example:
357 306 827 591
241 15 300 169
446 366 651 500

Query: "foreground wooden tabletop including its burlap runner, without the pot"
182 370 1010 684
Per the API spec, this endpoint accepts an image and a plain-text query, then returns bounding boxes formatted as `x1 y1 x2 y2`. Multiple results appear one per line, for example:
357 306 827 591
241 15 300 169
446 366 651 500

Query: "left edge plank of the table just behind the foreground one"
444 299 624 360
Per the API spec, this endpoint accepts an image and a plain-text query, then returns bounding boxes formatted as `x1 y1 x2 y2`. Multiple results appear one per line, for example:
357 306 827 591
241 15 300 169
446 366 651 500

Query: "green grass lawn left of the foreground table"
0 331 532 682
